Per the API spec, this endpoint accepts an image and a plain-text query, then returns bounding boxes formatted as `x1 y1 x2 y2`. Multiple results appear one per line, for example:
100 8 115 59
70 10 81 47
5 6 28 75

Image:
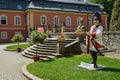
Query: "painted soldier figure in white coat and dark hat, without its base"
89 12 104 68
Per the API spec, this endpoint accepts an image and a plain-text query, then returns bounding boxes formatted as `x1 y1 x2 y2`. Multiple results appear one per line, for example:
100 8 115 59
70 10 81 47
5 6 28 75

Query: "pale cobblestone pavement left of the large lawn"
0 44 33 80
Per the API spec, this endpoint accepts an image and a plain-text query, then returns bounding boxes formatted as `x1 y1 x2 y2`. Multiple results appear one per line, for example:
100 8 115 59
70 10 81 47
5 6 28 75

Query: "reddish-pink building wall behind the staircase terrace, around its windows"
30 10 107 31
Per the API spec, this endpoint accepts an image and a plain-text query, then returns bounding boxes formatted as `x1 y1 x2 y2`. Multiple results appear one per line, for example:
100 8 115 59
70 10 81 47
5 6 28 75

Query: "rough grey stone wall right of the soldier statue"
103 31 120 52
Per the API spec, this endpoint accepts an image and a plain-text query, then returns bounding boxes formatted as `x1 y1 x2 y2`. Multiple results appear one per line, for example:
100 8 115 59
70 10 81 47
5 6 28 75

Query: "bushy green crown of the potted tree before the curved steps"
27 31 47 44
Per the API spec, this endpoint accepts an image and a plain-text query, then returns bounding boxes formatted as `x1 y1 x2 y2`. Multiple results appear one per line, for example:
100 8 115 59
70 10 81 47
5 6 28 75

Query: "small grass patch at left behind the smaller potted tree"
6 44 30 51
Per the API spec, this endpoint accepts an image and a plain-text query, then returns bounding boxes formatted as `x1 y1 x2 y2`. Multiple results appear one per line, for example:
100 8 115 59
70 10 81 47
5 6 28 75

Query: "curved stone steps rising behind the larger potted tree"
22 38 74 60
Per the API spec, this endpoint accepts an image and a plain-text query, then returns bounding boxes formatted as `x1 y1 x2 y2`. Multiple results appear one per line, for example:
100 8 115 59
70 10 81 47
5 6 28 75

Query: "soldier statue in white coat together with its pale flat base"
78 12 105 70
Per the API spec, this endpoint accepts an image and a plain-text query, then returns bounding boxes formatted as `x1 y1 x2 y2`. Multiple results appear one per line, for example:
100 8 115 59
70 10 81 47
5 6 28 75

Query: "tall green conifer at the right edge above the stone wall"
110 0 120 31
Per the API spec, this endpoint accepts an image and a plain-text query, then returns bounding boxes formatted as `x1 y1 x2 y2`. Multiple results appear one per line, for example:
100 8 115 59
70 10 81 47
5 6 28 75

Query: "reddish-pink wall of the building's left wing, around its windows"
0 10 27 42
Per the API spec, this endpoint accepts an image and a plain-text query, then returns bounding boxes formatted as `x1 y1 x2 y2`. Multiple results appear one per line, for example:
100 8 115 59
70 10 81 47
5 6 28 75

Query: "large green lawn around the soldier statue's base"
27 55 120 80
